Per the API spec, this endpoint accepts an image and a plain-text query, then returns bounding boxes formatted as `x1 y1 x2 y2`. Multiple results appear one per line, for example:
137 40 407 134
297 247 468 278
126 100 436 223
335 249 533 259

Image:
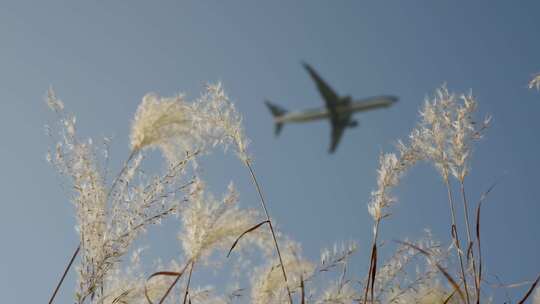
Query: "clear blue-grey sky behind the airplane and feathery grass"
0 0 540 303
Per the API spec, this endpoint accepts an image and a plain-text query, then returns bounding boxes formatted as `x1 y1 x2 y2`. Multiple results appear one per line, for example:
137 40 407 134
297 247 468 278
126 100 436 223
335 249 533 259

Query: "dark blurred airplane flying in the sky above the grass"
265 63 398 153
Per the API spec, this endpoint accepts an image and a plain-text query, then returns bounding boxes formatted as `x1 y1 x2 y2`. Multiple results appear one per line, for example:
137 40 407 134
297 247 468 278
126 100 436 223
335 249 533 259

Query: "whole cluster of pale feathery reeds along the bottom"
47 84 540 304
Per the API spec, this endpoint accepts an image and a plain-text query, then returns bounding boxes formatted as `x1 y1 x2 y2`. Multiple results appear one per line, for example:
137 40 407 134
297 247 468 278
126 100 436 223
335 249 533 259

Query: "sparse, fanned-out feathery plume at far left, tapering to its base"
47 89 191 303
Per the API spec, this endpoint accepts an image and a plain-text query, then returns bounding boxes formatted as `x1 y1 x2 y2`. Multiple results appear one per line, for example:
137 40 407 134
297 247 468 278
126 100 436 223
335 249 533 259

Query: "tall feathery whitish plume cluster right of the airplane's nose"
368 86 491 221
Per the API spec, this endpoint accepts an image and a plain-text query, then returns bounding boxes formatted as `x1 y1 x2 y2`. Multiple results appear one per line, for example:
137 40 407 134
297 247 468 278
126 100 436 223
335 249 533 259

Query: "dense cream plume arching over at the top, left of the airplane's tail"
130 83 248 163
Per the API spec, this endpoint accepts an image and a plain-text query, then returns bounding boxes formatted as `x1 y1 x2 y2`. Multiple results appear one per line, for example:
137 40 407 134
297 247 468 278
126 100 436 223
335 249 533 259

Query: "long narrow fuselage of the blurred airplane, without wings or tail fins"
274 96 397 123
